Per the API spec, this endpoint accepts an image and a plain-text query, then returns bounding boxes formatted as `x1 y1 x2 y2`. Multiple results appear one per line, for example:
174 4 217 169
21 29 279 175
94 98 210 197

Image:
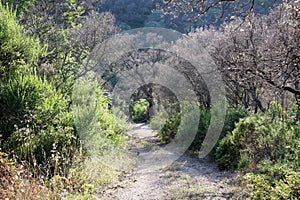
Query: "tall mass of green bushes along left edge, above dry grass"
0 4 79 178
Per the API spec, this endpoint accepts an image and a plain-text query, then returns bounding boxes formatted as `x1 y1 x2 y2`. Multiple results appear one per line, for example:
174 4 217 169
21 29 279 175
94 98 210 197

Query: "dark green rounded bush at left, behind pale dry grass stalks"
0 73 78 176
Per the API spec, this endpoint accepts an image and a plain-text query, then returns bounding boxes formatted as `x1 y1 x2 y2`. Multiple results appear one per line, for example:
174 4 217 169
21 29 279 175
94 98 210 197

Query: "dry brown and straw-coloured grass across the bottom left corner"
0 152 125 200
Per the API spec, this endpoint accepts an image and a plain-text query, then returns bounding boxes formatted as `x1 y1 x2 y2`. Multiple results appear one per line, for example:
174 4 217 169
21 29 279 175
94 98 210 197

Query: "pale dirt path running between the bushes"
99 124 245 200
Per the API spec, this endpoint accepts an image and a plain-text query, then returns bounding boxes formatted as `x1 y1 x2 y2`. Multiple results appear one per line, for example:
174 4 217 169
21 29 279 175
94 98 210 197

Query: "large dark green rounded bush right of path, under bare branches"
216 103 299 171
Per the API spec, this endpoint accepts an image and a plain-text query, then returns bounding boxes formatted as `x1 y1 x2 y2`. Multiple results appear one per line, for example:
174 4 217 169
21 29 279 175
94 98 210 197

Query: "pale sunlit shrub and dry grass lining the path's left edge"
68 77 128 196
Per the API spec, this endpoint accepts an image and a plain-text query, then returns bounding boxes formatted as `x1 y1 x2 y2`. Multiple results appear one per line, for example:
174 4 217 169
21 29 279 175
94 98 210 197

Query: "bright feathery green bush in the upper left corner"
0 4 43 78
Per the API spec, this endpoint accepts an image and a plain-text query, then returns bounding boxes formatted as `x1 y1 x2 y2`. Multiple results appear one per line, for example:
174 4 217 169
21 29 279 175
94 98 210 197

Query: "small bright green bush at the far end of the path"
129 99 149 122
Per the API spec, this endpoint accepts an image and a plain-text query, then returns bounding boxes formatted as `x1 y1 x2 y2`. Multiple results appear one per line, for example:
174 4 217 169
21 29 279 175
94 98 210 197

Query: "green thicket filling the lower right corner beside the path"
216 102 300 199
